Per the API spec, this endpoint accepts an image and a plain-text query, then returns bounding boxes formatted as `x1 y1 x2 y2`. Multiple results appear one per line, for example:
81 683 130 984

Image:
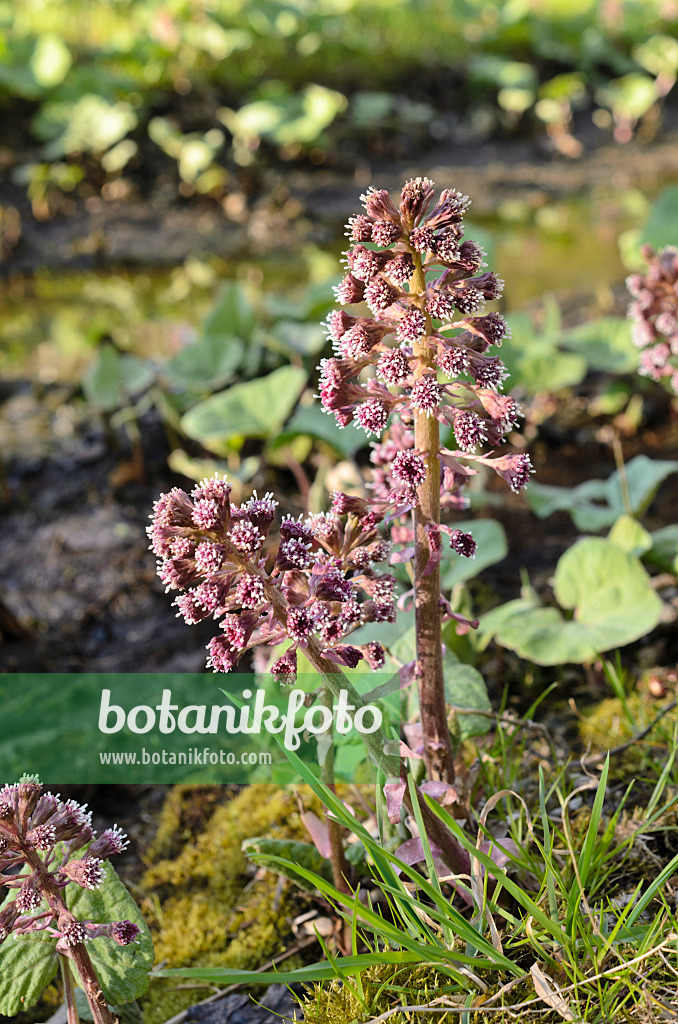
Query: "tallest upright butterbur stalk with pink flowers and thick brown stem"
320 178 532 782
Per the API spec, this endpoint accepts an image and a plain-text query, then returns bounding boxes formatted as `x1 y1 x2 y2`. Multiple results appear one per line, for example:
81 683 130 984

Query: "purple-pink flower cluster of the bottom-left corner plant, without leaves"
0 776 139 955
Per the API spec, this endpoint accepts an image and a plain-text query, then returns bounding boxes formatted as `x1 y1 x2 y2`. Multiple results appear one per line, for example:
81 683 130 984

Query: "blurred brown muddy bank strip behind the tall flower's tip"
0 131 678 278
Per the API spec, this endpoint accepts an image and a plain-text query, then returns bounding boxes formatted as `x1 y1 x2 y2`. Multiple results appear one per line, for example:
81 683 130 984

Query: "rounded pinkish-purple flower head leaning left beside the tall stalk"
147 477 395 682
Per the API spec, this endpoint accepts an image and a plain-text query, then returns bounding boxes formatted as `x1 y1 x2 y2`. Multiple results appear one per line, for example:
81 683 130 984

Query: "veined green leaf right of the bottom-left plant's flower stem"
66 861 154 1004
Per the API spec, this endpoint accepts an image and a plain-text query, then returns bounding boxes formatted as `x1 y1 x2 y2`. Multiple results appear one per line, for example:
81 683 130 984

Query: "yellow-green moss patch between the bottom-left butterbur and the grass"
140 785 317 1024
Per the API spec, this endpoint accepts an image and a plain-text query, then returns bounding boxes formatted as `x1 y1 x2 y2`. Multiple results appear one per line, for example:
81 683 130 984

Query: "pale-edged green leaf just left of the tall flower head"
181 367 306 455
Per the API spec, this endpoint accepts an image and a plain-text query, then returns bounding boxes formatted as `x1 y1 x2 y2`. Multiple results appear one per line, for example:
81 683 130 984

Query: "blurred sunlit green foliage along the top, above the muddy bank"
0 0 678 207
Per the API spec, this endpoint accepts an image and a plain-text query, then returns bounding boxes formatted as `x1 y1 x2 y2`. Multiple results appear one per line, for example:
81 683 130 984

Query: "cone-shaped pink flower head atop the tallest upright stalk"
319 178 532 507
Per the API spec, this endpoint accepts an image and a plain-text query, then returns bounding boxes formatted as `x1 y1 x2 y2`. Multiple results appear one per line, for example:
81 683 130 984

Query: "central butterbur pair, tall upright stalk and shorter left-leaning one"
149 178 532 870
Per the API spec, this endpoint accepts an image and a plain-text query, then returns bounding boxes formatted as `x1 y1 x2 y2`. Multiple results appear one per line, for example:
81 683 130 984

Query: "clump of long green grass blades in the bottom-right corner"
153 700 678 1024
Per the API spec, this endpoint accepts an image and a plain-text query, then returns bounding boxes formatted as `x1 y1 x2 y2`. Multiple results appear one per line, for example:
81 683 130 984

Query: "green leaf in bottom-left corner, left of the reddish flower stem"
0 933 58 1017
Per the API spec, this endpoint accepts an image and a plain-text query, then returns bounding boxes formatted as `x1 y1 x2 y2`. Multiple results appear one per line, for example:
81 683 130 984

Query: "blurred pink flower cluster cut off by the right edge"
626 246 678 394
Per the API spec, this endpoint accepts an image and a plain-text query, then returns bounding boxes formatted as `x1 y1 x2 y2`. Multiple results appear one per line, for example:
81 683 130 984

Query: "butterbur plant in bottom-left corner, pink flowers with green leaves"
0 776 153 1024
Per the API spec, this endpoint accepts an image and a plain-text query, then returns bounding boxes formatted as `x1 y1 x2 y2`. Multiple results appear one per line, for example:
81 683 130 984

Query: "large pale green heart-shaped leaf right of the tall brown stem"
479 537 662 665
